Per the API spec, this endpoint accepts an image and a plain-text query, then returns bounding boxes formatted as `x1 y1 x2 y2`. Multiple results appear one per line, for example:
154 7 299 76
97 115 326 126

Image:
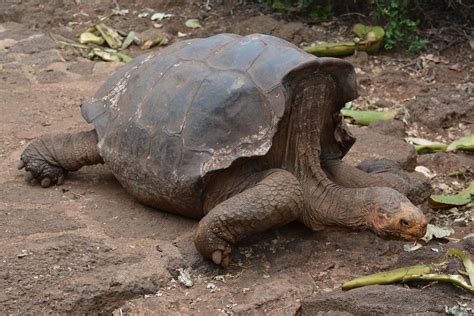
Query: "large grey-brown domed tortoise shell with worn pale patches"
82 34 356 217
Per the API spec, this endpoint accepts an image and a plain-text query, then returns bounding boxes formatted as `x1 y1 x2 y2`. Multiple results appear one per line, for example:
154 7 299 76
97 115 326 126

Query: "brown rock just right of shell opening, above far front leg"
344 126 416 171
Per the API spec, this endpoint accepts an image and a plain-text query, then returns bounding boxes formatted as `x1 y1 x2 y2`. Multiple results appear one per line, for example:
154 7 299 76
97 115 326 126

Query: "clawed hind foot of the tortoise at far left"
18 139 67 188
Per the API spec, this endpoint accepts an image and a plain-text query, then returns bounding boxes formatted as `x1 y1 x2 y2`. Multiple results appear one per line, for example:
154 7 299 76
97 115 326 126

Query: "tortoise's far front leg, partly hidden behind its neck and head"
322 160 431 204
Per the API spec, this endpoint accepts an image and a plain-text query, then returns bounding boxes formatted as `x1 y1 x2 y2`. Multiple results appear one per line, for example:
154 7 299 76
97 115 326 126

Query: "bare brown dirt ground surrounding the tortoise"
0 1 474 315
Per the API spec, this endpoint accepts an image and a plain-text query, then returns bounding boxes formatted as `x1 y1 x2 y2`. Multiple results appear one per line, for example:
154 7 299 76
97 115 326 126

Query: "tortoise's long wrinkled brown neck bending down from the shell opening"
279 70 370 229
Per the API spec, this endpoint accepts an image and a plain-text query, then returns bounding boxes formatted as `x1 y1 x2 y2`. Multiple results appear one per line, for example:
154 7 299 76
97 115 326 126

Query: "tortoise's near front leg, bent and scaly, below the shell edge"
194 169 303 267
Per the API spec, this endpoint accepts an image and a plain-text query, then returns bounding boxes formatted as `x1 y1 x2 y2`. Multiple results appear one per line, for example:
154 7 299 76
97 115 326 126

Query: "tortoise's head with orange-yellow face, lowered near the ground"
367 188 428 240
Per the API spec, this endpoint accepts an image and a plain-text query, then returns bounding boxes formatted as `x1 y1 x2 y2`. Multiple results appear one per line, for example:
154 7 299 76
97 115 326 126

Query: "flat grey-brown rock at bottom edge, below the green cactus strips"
300 285 450 315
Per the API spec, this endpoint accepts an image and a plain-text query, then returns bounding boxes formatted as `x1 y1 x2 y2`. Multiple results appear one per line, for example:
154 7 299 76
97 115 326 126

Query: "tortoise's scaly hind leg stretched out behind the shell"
18 130 103 187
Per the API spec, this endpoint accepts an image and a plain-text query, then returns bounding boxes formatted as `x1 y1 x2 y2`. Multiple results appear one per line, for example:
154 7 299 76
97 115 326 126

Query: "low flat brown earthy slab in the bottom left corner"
0 234 170 314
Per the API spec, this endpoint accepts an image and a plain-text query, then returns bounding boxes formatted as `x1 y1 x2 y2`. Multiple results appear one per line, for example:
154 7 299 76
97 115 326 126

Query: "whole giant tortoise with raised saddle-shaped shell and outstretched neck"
19 34 427 266
